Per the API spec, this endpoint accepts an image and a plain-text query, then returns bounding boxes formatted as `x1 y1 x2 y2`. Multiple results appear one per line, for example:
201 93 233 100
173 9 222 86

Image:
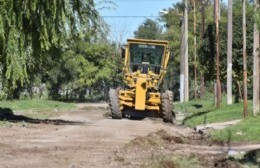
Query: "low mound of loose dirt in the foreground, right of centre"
114 129 242 168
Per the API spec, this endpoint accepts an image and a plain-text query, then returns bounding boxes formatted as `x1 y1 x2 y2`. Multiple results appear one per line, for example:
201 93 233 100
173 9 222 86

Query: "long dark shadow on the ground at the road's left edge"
0 108 84 125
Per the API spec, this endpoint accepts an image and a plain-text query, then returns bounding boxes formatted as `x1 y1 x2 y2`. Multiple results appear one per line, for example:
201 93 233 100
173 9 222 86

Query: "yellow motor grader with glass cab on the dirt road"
109 39 175 123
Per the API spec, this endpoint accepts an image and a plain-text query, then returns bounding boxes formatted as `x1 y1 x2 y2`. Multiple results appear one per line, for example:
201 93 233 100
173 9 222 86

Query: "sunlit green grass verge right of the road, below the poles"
175 99 260 142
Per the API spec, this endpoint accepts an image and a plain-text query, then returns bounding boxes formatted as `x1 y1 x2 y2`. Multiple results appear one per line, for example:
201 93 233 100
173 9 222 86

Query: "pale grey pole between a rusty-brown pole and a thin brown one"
227 0 233 105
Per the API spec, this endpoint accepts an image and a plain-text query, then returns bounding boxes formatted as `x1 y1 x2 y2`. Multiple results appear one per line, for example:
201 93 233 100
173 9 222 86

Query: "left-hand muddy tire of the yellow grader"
109 88 122 119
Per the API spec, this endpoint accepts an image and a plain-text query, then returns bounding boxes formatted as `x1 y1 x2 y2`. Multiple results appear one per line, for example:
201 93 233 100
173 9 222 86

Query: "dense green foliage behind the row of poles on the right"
159 0 255 99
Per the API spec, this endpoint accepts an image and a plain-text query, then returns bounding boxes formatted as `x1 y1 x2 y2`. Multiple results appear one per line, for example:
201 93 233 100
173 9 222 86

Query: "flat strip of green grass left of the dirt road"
0 100 76 110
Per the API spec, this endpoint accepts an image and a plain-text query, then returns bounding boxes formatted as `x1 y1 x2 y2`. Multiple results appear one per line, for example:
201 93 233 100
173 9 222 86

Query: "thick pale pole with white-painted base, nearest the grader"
180 0 189 102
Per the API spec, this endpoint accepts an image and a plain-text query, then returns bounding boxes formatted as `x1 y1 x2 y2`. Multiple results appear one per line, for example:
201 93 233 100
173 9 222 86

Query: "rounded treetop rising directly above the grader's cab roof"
134 19 162 40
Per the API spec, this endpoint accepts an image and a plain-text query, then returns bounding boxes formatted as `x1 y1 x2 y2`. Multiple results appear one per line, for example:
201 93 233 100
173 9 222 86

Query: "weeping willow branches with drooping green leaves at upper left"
0 0 102 98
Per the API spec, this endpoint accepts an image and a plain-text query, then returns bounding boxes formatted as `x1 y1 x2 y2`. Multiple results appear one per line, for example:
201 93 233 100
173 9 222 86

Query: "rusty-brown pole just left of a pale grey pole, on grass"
215 0 221 108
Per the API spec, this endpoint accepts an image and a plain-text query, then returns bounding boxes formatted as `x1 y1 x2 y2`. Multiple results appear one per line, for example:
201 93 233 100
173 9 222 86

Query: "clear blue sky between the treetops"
95 0 226 43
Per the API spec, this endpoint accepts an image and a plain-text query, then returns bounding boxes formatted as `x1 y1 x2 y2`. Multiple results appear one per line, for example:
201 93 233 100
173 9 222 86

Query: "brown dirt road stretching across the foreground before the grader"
0 104 258 168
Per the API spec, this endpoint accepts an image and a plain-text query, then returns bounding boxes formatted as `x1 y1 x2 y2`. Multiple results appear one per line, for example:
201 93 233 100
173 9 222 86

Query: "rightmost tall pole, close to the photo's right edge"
242 0 248 118
